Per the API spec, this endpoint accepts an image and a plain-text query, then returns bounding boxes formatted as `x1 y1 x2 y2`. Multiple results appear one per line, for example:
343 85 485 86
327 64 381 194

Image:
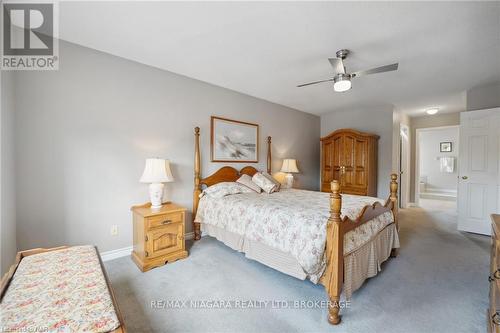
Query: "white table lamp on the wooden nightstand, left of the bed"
140 158 174 208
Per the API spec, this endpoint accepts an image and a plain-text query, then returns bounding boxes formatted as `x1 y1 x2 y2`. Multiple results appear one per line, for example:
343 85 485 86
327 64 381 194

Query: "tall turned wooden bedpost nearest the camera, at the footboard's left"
325 180 344 325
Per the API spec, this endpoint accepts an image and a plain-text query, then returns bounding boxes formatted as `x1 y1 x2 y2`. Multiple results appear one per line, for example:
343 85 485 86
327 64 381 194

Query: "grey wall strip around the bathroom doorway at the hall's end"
410 113 460 202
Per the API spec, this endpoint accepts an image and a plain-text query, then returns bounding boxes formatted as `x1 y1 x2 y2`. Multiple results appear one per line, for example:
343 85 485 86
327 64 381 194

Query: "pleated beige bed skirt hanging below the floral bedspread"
201 223 399 299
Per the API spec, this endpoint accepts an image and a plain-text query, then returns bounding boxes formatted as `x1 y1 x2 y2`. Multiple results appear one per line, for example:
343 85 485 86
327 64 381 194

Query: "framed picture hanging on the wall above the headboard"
210 116 259 163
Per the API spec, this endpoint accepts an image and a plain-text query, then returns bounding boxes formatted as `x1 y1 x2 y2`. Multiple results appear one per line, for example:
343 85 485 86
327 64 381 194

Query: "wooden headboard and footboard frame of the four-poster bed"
193 127 398 325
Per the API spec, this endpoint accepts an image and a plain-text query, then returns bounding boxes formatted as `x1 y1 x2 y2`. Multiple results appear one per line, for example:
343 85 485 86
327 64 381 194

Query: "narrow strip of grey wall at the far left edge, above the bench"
0 72 17 275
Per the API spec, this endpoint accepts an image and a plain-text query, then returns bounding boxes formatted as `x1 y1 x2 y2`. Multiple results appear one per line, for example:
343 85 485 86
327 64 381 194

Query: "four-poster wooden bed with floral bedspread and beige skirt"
193 127 399 325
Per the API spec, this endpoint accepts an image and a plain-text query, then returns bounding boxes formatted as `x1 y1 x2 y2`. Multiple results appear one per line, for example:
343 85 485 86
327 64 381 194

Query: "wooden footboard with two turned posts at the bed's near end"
320 174 398 325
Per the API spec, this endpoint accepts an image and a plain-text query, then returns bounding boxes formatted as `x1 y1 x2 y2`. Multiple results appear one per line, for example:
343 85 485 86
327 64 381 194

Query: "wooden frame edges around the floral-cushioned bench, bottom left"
0 246 127 333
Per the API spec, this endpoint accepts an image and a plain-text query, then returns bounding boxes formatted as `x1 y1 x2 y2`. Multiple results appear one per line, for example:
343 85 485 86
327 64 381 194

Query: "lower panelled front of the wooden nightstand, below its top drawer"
146 222 184 258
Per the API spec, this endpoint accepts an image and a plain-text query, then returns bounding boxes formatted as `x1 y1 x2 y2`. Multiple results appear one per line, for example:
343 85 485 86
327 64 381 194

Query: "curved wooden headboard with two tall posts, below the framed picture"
193 127 272 240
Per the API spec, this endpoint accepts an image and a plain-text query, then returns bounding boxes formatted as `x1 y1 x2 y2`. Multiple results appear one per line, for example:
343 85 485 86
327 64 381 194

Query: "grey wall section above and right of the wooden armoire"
321 106 393 198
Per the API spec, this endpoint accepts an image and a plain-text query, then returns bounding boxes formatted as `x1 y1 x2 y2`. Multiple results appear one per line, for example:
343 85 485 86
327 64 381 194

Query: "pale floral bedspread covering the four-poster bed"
196 189 394 283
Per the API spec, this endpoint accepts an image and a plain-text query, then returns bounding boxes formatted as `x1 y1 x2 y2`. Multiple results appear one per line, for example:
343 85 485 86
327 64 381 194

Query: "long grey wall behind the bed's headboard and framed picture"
16 41 320 251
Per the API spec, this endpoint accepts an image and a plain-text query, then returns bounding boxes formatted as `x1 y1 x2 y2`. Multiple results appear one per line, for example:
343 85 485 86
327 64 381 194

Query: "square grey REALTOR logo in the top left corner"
1 1 59 70
